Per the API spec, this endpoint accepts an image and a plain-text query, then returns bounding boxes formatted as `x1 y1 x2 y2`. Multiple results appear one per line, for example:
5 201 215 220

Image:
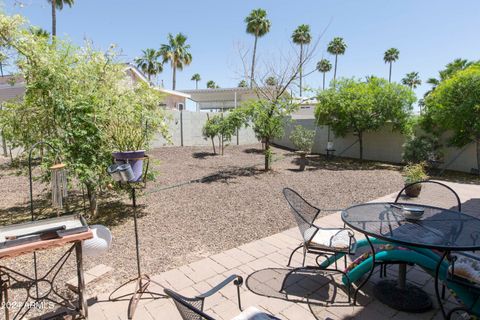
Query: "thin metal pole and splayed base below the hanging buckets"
108 184 168 320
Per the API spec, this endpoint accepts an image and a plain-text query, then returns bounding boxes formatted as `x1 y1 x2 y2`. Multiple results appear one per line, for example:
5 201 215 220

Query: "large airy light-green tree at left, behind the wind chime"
0 15 171 214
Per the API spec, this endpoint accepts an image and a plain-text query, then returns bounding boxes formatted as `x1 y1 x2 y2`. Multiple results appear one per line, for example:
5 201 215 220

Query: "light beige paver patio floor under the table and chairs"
89 183 480 320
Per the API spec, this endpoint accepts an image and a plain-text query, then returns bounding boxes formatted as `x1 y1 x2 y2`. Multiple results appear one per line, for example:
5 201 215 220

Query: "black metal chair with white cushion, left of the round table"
283 188 357 271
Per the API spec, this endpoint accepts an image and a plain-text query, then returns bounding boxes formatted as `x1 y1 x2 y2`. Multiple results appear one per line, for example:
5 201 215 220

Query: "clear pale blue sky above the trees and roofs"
0 0 480 106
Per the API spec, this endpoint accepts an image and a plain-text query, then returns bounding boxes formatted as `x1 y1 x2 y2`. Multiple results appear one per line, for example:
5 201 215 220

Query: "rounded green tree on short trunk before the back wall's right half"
315 78 415 160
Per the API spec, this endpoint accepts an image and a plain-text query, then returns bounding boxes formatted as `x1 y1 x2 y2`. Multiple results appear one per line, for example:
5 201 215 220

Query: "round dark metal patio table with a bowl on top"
342 202 480 317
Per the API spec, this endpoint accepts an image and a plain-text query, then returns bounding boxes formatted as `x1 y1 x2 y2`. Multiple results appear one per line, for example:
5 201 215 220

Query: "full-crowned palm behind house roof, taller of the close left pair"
160 33 192 90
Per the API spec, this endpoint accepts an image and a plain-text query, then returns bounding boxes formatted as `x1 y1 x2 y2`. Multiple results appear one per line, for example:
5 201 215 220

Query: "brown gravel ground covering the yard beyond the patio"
0 145 403 304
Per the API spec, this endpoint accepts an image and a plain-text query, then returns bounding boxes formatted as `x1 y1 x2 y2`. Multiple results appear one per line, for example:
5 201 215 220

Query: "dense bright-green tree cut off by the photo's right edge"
422 63 480 172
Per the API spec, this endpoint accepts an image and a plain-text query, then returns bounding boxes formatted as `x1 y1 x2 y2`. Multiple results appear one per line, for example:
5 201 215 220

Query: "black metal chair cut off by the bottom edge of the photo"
164 275 280 320
